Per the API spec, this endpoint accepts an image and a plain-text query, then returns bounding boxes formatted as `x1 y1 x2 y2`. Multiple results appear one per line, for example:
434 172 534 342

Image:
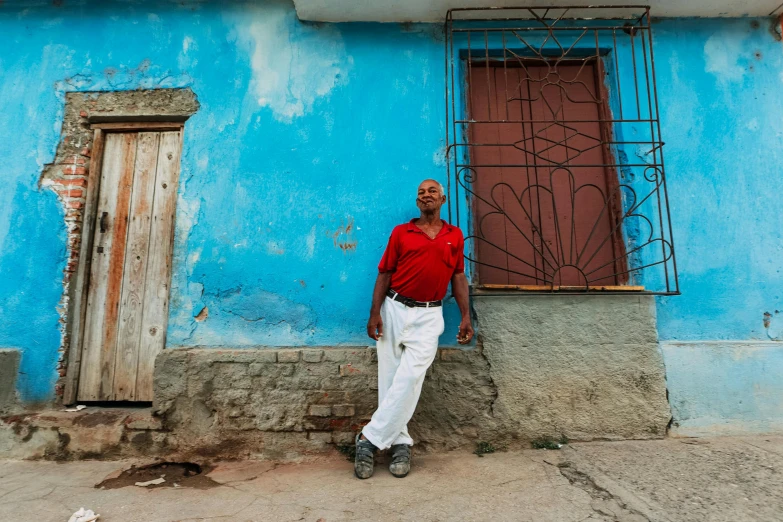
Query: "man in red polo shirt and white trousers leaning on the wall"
354 179 473 479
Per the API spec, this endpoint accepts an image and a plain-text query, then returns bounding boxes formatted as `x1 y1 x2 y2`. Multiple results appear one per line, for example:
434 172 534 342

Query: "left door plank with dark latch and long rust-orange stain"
78 134 136 401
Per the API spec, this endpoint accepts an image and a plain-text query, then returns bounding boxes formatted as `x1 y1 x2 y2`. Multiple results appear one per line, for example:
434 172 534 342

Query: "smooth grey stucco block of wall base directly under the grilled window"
474 296 671 440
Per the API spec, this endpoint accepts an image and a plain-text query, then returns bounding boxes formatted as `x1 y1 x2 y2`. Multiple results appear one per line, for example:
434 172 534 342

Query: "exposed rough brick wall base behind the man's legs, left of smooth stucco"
153 347 495 458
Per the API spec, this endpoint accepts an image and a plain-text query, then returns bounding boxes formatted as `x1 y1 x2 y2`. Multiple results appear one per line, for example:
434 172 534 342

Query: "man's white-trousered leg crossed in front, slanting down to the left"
363 307 443 450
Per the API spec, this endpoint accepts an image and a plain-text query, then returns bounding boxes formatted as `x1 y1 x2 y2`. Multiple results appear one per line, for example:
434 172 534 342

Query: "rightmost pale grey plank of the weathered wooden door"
136 132 181 401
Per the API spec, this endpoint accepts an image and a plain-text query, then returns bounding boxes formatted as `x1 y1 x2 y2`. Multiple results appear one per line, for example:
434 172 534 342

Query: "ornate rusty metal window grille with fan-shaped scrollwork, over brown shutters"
445 6 679 295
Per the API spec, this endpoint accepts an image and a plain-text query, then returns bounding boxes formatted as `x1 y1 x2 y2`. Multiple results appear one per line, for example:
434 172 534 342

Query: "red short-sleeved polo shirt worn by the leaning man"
378 219 465 301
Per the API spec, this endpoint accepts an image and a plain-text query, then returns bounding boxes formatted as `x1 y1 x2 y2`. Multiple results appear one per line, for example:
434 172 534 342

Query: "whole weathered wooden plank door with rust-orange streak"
78 131 181 401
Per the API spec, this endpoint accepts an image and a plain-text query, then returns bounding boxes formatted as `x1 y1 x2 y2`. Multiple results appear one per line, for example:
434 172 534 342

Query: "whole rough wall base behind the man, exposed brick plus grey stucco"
154 296 671 458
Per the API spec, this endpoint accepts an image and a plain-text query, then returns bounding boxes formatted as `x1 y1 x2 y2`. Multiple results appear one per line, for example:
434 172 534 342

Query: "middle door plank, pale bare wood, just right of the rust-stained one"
112 132 160 401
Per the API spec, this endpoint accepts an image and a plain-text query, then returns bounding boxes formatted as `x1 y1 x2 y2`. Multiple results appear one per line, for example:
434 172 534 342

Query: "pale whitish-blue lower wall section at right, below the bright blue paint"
661 341 783 437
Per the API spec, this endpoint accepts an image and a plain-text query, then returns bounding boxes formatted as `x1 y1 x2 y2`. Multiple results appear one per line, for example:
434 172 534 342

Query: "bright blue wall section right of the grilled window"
654 19 783 341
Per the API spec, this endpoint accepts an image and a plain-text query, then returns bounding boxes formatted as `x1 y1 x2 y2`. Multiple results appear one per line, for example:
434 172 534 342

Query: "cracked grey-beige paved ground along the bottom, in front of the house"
0 436 783 522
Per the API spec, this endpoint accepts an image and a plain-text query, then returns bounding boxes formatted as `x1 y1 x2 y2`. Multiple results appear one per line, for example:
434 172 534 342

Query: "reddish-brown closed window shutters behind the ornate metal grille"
468 60 627 286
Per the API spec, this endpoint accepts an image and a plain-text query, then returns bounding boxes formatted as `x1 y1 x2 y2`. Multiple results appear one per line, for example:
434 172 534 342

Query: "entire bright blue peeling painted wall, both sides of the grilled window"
0 1 783 408
